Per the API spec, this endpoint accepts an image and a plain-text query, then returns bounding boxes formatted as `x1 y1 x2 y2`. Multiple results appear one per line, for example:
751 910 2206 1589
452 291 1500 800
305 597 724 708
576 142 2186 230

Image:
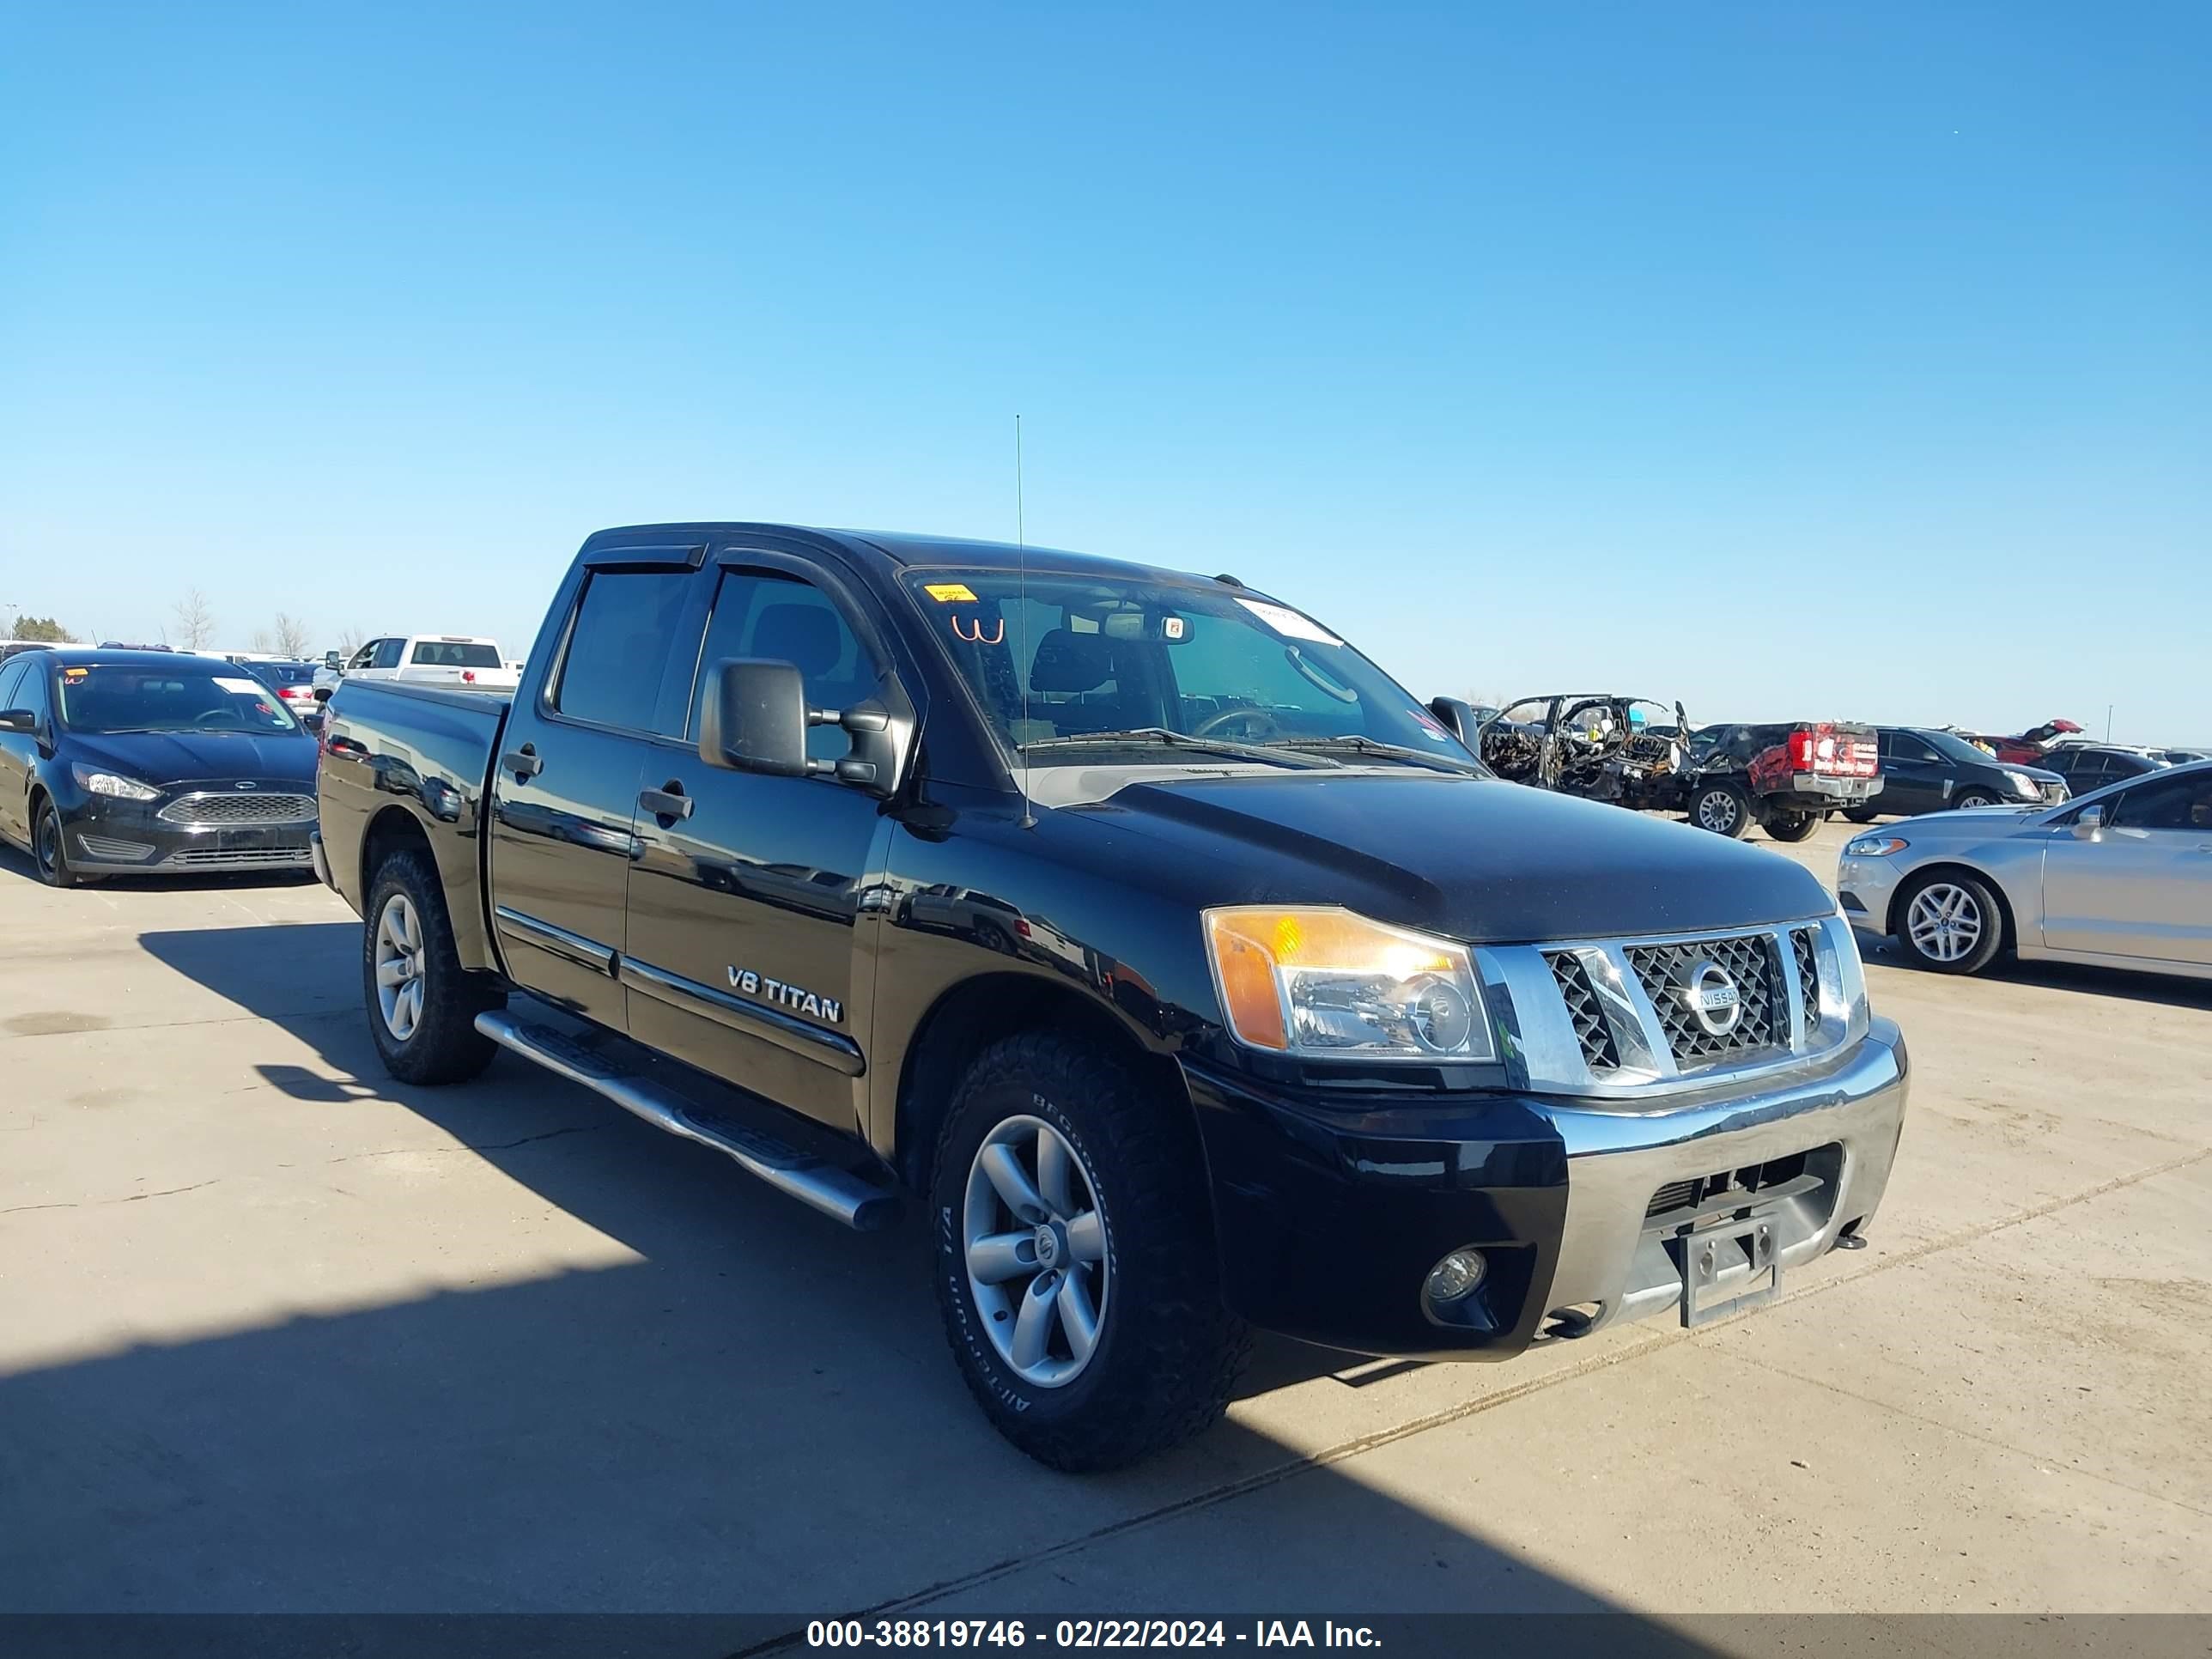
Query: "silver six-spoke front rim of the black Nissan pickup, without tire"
963 1115 1113 1389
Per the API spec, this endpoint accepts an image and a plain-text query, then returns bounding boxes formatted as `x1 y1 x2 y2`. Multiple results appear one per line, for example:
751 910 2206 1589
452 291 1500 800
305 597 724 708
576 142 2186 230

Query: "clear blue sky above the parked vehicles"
0 0 2212 741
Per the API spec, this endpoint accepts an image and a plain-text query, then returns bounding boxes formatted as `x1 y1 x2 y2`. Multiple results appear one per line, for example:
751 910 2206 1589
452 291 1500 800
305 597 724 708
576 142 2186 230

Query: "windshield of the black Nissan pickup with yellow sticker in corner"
909 571 1467 765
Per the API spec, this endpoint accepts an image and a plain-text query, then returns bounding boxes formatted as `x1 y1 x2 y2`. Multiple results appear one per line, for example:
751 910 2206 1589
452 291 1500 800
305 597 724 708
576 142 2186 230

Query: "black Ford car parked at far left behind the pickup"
0 646 316 887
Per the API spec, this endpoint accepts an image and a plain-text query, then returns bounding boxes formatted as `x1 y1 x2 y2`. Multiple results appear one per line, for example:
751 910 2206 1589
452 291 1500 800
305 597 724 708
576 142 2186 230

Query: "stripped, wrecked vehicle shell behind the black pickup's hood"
1474 692 1687 811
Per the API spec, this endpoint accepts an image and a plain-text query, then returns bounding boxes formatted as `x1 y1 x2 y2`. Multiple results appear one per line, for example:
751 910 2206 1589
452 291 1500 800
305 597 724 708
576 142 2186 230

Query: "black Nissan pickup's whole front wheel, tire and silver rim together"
929 1030 1249 1474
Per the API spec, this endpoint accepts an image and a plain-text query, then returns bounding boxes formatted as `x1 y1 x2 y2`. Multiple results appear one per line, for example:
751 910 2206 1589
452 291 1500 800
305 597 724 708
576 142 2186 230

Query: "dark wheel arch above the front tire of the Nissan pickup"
890 973 1194 1192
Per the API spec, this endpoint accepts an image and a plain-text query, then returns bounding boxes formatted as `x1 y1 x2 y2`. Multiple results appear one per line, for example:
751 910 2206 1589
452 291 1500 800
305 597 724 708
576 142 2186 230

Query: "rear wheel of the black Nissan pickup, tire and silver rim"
361 849 504 1084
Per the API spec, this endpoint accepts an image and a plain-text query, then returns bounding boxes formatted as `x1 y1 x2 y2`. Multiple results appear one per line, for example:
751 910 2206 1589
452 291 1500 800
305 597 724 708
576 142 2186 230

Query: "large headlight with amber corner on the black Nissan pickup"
1206 905 1498 1060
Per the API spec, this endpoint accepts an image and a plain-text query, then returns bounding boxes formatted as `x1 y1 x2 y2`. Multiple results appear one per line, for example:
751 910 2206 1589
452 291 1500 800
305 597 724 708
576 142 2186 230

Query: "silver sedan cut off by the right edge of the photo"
1836 761 2212 978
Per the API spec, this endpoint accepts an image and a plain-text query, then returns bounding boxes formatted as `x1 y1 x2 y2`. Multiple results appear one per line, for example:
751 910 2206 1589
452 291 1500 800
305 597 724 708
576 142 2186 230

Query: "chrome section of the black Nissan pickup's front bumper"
1548 1020 1907 1329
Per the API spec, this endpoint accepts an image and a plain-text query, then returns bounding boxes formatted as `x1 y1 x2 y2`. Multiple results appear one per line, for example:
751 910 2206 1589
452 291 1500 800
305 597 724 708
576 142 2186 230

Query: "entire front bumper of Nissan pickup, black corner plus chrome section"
1183 1020 1907 1360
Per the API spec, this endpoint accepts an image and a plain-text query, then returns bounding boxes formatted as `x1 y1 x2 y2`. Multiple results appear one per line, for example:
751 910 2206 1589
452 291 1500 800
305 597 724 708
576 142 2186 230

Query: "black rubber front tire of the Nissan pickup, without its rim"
929 1030 1252 1474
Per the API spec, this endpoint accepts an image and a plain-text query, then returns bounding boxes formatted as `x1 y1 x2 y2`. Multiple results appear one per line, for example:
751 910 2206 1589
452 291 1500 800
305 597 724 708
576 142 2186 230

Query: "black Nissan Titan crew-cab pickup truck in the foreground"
316 525 1907 1468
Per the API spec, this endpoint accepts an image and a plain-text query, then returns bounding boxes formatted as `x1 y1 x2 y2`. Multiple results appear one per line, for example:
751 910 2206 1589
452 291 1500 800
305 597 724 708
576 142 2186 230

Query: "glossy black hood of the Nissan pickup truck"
1082 769 1836 945
